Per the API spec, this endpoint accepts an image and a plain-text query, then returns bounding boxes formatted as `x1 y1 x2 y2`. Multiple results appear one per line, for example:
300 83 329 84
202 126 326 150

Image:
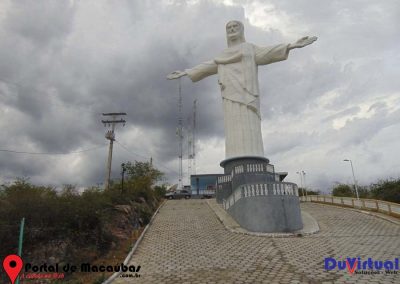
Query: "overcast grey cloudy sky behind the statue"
0 0 400 191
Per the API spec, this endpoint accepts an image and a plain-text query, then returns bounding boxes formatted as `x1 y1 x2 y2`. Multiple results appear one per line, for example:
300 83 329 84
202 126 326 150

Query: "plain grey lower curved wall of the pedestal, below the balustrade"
228 195 303 233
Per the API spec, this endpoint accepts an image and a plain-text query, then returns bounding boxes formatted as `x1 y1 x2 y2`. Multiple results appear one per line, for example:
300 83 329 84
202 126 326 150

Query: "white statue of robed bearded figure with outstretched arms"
167 21 317 159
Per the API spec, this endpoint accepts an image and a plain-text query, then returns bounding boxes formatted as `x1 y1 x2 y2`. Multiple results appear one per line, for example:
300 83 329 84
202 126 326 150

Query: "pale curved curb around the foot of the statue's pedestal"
207 200 319 238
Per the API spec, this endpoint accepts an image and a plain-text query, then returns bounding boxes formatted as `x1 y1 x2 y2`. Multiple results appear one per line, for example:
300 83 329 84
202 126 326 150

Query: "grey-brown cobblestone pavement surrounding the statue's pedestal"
113 200 400 283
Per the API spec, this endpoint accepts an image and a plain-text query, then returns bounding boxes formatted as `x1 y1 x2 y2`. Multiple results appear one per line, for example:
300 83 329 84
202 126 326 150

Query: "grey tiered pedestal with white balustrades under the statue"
216 156 303 233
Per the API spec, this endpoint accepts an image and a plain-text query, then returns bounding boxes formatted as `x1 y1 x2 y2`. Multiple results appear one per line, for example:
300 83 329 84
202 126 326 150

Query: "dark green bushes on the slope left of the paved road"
0 163 161 262
